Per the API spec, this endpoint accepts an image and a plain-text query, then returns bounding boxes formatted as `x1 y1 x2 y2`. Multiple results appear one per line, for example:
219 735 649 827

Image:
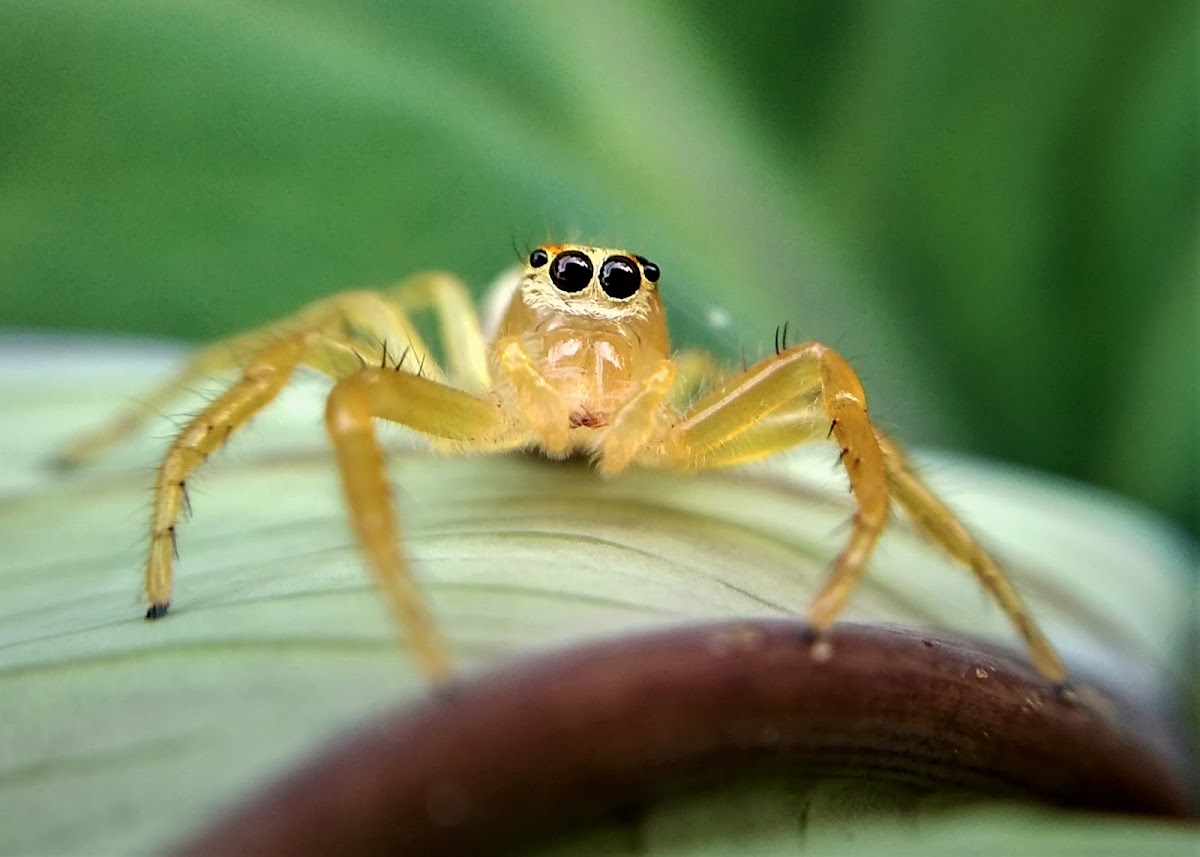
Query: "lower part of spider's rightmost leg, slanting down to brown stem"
876 432 1067 687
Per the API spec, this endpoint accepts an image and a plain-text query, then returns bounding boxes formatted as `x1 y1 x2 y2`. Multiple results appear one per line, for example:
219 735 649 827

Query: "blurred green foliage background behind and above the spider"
0 0 1200 532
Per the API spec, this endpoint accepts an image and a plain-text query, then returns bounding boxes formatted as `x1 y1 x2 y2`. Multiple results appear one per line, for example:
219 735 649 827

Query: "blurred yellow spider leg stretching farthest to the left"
53 290 444 468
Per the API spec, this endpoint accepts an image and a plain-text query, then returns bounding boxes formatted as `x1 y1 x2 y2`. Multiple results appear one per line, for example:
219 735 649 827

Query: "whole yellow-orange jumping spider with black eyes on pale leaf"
59 244 1067 688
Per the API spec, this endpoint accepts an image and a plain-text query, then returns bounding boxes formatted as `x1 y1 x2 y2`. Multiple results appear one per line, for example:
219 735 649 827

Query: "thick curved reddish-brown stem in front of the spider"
176 621 1196 857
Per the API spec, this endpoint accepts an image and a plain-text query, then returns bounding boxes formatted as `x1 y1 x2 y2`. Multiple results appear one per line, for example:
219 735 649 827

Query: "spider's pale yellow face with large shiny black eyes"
521 244 661 322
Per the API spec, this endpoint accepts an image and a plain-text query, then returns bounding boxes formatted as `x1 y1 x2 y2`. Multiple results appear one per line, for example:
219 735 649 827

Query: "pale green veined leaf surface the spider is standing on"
0 338 1190 855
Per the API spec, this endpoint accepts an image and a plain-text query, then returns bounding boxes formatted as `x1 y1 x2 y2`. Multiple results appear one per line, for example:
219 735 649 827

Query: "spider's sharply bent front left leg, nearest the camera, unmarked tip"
325 366 515 679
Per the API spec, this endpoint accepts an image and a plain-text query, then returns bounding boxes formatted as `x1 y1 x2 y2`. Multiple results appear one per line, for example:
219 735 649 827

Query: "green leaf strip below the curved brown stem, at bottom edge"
536 783 1200 857
